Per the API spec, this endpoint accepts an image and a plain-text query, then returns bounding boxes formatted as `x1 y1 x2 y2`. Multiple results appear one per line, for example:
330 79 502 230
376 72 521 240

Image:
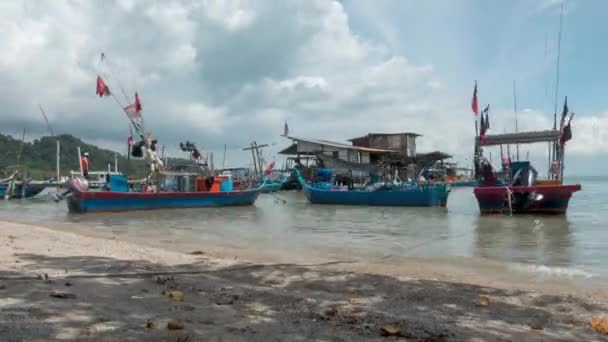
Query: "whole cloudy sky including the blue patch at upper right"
0 0 608 174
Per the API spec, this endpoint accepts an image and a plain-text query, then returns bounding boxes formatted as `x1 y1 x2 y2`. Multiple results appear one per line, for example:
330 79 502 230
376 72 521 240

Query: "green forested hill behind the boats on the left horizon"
0 134 148 179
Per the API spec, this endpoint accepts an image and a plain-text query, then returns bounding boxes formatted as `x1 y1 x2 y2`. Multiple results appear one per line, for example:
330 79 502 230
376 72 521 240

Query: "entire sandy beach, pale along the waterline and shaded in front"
0 222 608 341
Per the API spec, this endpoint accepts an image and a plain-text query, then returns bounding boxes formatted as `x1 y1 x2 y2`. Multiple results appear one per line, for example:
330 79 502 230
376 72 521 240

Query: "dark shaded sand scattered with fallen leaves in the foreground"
0 256 607 342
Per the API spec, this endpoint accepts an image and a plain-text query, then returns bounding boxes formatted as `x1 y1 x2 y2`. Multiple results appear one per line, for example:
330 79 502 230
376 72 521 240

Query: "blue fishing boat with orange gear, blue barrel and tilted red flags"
56 71 265 213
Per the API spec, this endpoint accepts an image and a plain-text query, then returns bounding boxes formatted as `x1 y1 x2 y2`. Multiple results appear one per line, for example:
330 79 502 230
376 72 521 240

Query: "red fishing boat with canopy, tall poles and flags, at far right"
472 6 581 214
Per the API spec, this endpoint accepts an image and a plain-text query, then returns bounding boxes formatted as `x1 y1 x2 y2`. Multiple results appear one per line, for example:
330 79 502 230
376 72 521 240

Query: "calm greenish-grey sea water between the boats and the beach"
0 178 608 288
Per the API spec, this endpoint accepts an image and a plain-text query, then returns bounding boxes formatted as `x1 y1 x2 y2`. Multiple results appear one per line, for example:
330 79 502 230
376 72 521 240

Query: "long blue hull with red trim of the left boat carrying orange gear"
67 189 260 213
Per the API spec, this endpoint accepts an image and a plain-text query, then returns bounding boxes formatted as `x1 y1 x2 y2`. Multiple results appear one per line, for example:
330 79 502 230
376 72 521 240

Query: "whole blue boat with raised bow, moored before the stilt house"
297 171 449 207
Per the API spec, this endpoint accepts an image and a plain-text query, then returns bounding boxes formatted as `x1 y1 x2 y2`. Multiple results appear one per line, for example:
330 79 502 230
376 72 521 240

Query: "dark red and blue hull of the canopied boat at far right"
473 184 581 214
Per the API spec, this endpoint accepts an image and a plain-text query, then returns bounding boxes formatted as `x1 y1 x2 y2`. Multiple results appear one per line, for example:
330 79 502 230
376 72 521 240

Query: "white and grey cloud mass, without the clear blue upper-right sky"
0 0 608 175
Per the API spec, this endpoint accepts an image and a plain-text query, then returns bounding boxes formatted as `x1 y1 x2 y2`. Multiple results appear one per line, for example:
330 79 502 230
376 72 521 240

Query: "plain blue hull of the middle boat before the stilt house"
302 185 449 207
